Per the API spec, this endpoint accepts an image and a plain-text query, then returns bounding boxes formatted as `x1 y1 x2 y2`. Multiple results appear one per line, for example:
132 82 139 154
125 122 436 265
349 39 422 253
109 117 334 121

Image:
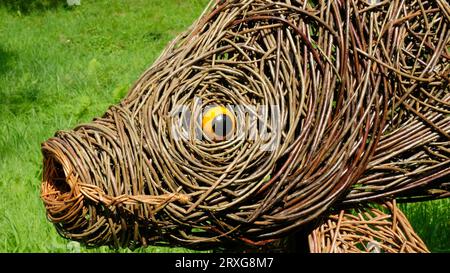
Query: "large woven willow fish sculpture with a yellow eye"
42 0 450 252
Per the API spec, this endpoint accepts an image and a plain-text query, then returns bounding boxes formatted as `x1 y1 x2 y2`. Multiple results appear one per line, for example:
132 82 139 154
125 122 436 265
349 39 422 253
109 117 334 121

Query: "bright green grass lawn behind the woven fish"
0 0 450 252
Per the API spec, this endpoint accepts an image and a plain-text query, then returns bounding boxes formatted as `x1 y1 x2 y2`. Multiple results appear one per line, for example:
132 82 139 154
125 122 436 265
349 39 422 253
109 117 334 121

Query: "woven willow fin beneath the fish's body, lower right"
308 202 429 253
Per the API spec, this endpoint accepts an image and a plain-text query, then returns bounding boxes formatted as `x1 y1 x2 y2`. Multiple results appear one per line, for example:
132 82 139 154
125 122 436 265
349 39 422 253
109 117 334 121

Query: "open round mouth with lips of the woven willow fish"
41 137 111 246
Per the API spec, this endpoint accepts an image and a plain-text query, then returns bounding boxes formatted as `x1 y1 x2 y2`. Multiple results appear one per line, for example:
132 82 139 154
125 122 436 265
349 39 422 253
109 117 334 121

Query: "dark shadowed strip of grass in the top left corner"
0 0 67 14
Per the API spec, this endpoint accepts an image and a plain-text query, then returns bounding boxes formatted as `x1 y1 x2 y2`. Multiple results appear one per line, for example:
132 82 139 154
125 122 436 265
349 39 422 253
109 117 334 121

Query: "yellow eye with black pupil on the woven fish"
202 106 236 141
